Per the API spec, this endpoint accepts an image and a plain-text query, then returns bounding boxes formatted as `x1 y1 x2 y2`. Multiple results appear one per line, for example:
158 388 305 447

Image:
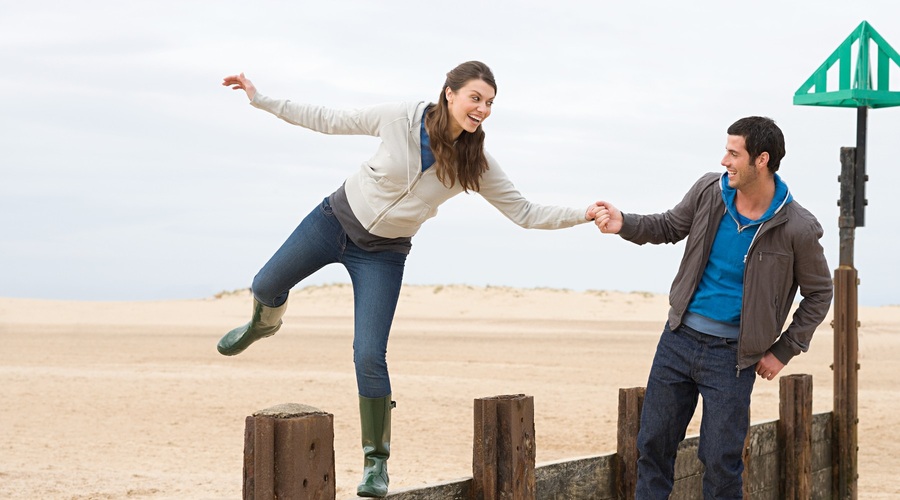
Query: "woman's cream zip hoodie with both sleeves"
251 93 587 238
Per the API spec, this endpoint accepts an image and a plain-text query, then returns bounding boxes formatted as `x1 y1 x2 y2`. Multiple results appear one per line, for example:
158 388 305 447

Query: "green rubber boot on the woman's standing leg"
356 394 396 498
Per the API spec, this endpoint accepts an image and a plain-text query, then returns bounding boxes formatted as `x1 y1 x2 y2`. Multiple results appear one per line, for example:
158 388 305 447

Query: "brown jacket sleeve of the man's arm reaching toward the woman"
619 174 719 245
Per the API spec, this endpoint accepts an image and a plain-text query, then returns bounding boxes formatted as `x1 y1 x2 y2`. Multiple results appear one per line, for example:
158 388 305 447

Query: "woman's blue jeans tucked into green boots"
252 198 406 398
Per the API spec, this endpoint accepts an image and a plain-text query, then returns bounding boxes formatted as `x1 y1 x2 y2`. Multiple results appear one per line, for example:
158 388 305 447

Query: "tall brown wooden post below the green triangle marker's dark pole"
832 265 859 500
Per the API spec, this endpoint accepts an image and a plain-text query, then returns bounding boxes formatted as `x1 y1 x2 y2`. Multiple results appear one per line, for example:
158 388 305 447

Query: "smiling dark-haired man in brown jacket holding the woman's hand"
595 116 832 499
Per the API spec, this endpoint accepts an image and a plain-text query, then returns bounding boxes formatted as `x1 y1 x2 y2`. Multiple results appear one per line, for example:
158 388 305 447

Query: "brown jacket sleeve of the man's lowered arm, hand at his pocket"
770 214 834 364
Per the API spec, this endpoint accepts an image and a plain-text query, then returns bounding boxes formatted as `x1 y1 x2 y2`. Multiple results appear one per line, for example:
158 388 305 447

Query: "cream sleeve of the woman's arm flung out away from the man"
250 92 406 136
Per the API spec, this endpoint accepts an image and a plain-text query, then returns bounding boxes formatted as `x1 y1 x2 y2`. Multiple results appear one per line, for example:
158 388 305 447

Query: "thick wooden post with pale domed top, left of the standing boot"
244 403 335 500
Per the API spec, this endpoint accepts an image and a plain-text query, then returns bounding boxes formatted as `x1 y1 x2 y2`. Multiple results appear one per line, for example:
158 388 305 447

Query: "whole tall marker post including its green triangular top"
794 21 900 499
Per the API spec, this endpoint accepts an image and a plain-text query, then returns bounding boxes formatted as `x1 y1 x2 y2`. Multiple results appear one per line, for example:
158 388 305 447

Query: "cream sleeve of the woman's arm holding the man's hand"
478 152 588 229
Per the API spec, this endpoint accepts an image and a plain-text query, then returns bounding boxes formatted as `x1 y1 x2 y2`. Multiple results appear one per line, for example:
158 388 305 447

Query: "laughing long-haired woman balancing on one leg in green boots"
218 61 597 497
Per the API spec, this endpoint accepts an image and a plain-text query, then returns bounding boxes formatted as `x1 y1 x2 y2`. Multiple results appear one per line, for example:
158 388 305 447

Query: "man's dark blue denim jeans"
635 324 756 499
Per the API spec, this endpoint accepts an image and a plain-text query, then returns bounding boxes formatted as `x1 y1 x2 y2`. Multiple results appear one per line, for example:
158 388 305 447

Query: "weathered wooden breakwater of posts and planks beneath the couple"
237 375 835 500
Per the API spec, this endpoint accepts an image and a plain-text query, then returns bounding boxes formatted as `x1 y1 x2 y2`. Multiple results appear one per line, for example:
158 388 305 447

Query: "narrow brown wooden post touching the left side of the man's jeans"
616 387 646 499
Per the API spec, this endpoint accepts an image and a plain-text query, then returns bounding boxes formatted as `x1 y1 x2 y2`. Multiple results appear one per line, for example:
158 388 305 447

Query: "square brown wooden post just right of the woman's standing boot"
472 394 536 500
